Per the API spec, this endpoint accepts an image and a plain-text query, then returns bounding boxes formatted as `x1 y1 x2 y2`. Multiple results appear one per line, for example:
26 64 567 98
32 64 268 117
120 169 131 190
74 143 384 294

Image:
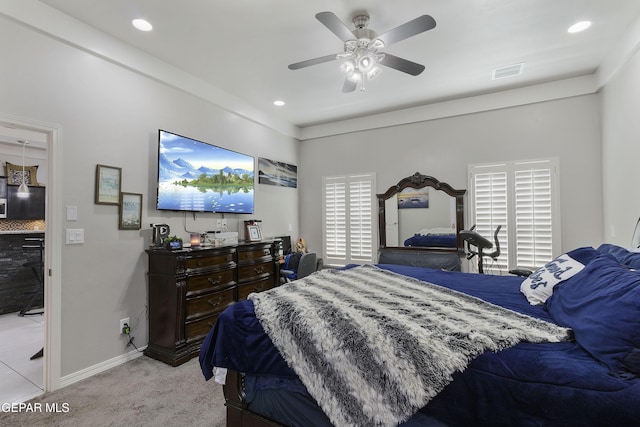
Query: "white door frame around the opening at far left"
0 113 63 392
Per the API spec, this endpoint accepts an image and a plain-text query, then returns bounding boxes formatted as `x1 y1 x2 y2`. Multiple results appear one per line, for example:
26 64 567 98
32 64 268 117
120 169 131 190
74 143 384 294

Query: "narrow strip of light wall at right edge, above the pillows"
601 45 640 246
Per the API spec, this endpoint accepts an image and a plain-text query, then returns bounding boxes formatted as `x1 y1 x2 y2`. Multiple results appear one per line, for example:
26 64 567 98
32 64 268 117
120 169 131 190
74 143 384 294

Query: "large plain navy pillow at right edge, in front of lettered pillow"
546 255 640 376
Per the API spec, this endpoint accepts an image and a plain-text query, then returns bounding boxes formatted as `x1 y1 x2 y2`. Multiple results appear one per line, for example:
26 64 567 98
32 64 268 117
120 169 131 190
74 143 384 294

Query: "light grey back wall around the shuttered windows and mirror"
298 95 603 260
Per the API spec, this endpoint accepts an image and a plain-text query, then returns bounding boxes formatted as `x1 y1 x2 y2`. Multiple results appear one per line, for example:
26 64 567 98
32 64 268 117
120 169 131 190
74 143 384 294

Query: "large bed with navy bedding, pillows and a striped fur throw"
200 245 640 427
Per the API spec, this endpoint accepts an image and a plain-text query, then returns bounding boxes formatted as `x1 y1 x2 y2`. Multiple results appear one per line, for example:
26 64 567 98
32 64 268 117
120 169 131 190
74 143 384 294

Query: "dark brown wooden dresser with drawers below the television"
145 241 280 366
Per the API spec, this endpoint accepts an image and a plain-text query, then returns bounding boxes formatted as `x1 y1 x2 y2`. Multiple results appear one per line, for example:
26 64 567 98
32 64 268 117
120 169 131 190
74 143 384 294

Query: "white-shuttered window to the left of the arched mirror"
322 174 376 265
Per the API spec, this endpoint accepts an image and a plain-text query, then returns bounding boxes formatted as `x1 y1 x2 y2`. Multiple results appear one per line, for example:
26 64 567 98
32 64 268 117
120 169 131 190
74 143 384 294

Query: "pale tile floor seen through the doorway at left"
0 310 44 404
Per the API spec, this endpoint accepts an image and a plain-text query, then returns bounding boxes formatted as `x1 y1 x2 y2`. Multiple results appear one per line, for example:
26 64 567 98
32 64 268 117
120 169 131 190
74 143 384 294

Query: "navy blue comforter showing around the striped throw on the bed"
200 265 640 426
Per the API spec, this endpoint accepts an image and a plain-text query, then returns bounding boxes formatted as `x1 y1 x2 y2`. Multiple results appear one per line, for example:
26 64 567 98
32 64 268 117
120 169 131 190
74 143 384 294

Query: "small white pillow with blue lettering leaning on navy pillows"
520 246 598 305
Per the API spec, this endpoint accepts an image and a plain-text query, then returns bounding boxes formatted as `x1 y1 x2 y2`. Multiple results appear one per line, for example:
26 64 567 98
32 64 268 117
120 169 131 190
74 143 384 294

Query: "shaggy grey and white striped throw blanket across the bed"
249 265 570 427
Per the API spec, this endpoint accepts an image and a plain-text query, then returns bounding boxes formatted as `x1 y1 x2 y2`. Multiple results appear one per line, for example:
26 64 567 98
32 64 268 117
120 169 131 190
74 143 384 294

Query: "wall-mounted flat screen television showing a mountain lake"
157 129 255 214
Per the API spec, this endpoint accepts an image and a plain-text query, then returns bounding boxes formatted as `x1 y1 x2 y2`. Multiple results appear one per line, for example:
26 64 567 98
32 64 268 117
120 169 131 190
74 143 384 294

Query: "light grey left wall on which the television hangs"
0 17 298 376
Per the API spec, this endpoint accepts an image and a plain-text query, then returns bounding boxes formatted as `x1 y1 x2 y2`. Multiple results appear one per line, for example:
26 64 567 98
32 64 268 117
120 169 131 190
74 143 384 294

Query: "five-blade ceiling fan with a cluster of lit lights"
289 12 436 92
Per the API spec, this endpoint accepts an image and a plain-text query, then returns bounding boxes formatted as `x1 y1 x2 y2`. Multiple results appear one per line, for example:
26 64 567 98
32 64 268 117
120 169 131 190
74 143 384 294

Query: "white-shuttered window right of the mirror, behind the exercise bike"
469 159 560 273
